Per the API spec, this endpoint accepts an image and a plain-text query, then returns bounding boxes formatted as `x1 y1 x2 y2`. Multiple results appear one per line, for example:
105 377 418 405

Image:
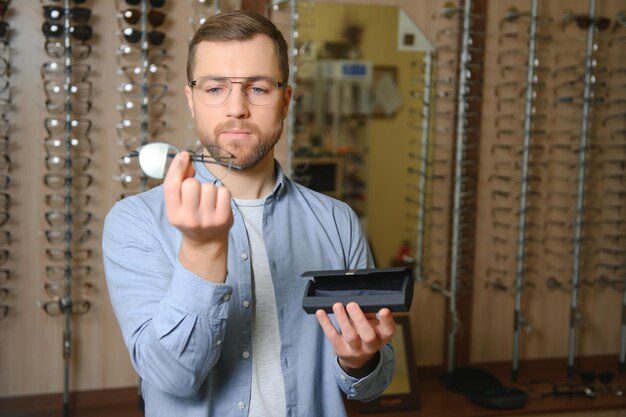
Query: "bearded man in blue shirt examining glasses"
103 11 395 417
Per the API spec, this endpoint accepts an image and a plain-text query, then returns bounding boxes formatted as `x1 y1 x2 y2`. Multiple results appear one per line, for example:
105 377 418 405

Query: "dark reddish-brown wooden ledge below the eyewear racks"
0 357 626 417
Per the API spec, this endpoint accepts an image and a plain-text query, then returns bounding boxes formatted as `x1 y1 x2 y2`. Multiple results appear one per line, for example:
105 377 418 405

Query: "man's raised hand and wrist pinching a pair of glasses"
163 152 233 283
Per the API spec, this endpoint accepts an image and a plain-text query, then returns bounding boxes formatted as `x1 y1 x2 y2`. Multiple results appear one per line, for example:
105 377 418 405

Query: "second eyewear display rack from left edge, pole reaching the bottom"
42 0 91 416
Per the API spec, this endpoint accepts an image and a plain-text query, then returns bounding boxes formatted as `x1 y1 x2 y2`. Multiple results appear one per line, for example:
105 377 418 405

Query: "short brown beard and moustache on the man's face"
196 119 283 169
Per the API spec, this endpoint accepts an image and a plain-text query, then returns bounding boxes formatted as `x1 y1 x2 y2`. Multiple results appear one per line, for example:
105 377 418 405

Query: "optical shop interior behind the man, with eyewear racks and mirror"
0 0 626 417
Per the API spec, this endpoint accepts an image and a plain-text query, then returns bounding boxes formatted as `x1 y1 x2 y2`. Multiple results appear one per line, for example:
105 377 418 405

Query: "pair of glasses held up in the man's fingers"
124 142 241 179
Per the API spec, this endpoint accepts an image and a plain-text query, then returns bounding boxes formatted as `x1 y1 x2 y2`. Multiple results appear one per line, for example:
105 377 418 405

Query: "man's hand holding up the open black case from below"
315 302 396 378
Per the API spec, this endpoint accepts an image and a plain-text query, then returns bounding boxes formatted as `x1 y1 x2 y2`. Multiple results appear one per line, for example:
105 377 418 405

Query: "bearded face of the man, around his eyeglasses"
185 36 291 168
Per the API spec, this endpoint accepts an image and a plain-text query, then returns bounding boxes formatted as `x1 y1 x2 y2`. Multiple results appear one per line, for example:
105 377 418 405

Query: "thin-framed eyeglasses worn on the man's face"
188 76 287 106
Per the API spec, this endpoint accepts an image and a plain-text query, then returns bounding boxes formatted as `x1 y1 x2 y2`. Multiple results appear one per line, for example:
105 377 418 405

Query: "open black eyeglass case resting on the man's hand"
301 267 414 314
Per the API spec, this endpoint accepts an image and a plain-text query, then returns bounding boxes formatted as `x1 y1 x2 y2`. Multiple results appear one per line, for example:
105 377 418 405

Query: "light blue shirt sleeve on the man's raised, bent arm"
102 198 232 396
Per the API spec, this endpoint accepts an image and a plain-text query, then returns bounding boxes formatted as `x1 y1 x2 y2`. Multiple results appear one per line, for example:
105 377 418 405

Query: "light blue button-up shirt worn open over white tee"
103 163 395 417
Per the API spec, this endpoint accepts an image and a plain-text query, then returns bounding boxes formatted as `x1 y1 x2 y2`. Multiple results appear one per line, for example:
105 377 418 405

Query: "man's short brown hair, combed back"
187 10 289 82
